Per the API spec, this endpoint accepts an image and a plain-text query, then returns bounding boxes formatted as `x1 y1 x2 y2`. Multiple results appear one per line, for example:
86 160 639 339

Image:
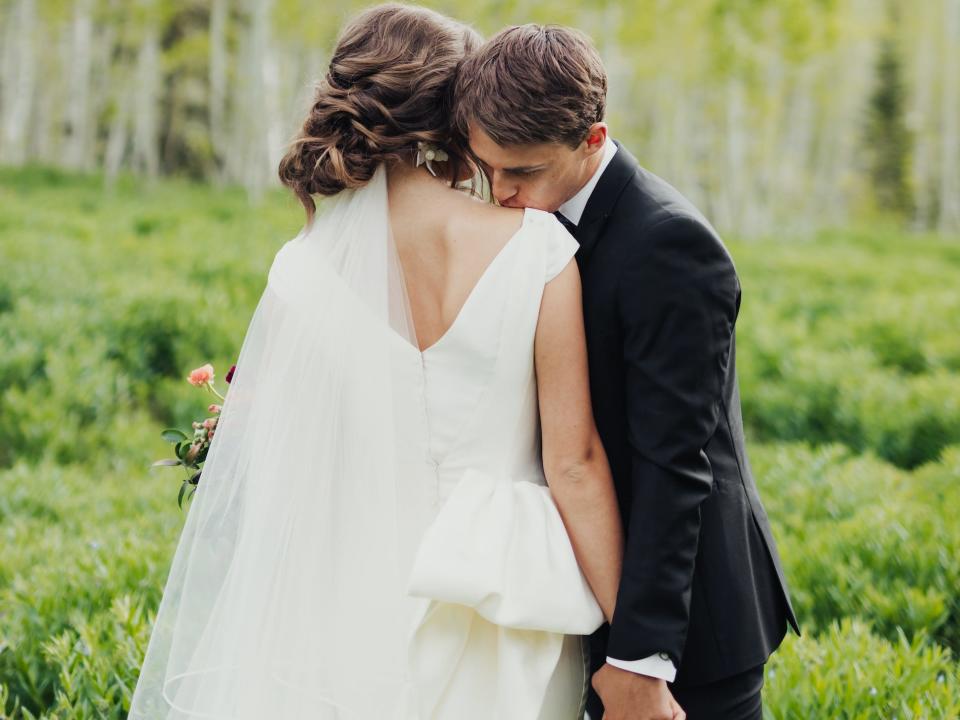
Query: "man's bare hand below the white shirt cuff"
593 664 687 720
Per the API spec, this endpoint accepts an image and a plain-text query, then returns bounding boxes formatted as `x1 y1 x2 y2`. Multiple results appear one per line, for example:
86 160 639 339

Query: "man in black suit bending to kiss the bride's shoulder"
454 25 799 720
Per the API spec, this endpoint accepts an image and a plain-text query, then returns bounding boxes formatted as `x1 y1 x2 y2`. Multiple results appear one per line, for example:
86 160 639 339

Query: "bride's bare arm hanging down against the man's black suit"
535 261 623 622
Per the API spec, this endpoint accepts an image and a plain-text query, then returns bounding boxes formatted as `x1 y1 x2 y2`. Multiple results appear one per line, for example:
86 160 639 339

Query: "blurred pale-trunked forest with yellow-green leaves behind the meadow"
0 0 960 236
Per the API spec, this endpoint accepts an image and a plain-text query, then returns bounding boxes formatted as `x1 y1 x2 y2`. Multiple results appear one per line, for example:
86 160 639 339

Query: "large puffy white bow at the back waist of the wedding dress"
407 468 603 635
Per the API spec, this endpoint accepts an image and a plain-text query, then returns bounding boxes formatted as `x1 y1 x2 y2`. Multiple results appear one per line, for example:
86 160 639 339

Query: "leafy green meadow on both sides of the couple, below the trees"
0 168 960 719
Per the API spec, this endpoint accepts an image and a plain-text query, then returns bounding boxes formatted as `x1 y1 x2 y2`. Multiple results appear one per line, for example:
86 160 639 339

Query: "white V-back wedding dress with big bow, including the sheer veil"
130 170 603 720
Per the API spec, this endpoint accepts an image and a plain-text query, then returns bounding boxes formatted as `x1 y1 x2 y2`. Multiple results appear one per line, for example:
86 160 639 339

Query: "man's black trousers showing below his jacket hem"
587 665 763 720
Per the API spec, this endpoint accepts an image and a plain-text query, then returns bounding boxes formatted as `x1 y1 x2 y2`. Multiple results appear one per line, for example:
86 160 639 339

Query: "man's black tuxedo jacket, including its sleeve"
574 146 799 688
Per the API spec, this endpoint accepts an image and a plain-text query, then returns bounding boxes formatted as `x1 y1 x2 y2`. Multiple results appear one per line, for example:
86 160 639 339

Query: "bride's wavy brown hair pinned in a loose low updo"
279 4 481 222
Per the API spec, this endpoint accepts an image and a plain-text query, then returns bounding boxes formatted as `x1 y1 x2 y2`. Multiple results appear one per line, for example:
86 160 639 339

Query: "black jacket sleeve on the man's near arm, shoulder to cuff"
607 216 740 667
